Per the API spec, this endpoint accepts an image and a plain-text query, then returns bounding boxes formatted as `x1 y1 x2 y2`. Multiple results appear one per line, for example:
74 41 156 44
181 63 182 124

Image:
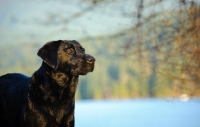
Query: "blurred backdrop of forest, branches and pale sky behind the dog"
0 0 200 99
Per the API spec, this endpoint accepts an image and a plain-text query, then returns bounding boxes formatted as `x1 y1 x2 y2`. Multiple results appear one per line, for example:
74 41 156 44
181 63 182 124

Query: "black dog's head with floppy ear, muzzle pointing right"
37 40 95 75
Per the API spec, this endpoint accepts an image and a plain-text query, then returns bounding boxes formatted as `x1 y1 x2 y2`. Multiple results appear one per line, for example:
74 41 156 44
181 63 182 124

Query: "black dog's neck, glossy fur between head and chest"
32 62 78 103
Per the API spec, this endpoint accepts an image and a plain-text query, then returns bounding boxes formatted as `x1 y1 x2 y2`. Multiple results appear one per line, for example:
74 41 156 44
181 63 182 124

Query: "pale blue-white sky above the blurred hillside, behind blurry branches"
0 0 199 44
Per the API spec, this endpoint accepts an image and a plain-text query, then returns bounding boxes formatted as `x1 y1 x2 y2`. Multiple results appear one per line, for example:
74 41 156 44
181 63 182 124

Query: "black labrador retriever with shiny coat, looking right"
0 40 95 127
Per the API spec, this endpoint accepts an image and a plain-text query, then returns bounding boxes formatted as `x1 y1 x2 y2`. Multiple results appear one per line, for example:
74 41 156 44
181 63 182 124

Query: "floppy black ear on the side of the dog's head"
37 40 62 69
